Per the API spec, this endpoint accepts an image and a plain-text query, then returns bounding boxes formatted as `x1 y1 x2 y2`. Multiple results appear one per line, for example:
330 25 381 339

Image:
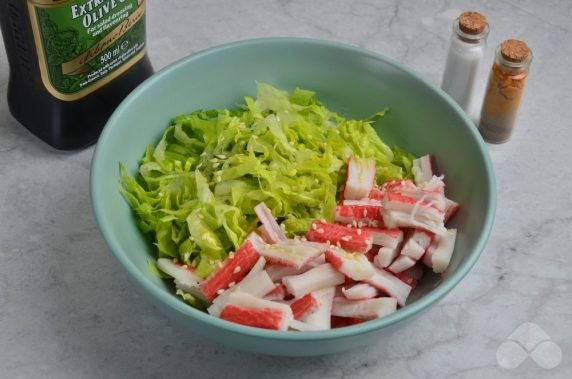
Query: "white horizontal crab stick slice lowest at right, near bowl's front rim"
332 297 397 319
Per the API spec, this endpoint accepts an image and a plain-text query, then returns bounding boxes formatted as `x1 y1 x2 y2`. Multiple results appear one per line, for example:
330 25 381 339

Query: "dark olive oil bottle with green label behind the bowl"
0 0 153 150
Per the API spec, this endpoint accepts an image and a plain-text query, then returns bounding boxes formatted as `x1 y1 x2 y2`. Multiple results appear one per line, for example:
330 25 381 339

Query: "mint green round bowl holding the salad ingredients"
91 38 496 356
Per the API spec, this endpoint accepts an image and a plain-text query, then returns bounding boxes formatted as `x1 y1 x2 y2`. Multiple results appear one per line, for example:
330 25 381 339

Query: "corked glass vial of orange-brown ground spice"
479 39 532 143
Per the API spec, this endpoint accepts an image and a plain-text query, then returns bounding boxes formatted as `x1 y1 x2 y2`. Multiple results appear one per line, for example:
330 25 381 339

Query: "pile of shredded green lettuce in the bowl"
120 84 414 277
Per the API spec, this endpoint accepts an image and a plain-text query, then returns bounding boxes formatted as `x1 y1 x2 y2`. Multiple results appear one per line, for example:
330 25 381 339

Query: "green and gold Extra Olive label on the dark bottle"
28 0 146 101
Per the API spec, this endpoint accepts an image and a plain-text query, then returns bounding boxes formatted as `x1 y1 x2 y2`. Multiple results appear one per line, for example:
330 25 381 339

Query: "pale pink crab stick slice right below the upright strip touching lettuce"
248 235 327 270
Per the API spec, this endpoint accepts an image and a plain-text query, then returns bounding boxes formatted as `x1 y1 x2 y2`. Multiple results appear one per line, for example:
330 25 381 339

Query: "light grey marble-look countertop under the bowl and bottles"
0 0 572 379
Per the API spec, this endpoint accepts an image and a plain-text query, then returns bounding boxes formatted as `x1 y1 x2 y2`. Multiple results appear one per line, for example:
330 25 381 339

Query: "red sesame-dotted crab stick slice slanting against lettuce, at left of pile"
200 240 259 301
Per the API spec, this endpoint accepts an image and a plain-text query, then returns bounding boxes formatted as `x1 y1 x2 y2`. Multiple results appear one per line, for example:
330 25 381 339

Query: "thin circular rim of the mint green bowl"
90 37 497 341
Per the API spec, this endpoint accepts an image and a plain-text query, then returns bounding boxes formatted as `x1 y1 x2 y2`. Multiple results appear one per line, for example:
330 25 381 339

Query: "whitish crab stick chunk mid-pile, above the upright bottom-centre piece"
282 263 346 299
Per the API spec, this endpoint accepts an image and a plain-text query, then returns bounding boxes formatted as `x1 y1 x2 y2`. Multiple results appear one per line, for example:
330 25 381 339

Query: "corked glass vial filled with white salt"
441 11 489 113
